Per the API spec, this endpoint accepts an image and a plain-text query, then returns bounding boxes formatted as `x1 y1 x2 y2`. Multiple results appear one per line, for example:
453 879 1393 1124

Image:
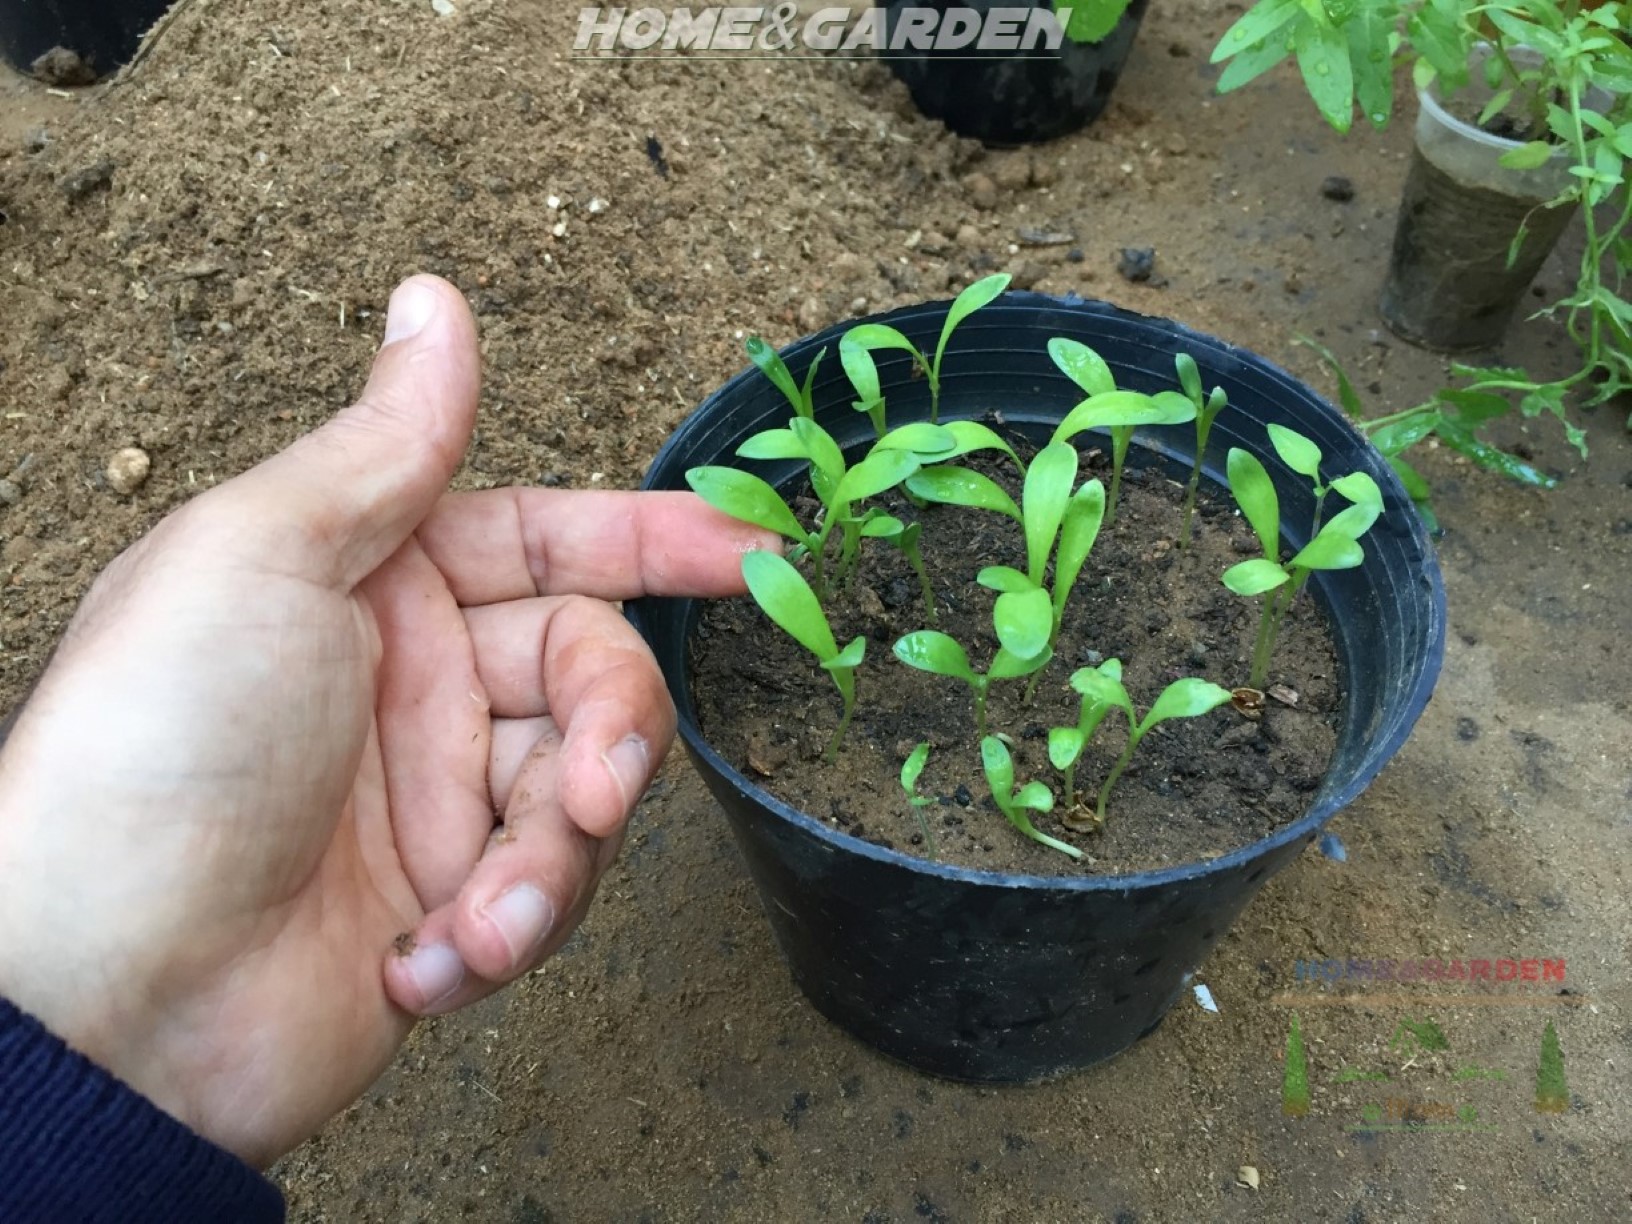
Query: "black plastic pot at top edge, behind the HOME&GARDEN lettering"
885 0 1149 145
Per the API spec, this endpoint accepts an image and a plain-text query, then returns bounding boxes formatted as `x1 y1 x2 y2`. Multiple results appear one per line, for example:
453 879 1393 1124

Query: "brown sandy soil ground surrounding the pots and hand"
0 0 1632 1224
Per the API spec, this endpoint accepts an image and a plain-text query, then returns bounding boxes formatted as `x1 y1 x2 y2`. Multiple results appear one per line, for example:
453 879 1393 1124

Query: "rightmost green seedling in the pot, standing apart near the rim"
1224 447 1382 689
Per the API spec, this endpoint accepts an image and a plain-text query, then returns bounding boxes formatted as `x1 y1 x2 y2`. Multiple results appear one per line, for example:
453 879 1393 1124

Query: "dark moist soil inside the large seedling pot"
692 450 1342 875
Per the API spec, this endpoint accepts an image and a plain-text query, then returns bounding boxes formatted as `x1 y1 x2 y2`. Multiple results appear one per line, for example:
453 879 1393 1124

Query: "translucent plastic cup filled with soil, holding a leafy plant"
1381 51 1577 353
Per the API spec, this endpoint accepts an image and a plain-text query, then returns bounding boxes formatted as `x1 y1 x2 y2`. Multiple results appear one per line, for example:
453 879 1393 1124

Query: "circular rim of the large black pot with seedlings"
625 290 1448 894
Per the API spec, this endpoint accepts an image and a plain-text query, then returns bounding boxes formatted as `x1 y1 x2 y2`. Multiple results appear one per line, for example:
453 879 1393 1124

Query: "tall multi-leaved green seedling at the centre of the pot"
976 442 1105 700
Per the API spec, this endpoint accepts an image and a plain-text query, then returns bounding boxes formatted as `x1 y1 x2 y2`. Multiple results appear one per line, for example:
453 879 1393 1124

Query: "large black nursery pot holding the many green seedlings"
630 294 1446 1084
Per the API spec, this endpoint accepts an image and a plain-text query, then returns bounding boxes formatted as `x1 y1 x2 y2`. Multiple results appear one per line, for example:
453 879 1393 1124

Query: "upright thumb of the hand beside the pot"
215 276 481 591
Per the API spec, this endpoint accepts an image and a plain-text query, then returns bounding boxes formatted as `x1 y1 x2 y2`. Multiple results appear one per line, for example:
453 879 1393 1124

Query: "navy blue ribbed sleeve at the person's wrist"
0 999 284 1224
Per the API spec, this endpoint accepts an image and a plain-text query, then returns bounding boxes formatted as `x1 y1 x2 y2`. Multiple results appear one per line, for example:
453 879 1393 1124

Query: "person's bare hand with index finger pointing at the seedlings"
0 277 770 1164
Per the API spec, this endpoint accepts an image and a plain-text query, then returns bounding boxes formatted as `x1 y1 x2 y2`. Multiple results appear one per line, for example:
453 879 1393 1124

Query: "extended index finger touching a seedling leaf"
418 488 778 607
